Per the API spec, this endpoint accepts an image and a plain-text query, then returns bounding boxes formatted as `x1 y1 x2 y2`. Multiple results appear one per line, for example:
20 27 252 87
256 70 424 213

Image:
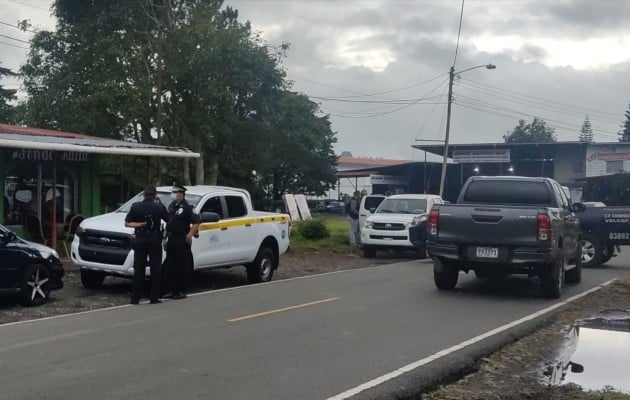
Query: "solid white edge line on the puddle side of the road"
327 278 617 400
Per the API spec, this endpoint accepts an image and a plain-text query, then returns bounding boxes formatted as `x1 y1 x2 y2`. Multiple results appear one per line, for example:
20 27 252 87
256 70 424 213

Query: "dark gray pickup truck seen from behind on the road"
426 176 584 298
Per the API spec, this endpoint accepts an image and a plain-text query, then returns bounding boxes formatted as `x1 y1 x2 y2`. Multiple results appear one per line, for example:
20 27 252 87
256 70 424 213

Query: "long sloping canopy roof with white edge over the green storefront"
0 124 201 158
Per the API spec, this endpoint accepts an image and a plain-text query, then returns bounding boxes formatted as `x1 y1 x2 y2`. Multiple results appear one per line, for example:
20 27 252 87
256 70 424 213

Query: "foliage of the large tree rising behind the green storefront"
22 0 336 202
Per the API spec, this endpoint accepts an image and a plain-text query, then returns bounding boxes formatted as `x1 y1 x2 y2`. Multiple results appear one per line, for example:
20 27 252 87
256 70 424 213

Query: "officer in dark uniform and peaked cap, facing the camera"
163 184 199 299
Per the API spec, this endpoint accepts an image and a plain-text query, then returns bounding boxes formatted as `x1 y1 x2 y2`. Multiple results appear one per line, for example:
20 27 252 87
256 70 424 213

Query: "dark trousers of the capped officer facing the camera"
164 235 193 293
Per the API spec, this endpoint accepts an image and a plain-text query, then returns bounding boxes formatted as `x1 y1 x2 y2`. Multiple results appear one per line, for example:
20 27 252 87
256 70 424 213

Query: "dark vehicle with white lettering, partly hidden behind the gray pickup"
577 202 630 267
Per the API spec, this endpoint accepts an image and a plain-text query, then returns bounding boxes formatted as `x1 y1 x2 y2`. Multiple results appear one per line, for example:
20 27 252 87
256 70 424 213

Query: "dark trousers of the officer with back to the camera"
131 237 162 300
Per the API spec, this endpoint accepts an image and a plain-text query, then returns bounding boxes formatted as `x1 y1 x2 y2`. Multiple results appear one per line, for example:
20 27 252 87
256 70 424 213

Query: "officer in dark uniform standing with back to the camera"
125 185 168 304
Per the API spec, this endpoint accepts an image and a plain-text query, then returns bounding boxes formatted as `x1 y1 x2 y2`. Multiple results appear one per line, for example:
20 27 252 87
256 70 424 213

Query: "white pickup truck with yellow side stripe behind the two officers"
71 186 291 288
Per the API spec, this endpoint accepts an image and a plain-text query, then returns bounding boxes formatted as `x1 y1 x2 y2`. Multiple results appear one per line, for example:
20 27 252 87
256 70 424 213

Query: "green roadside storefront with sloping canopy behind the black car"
0 124 200 252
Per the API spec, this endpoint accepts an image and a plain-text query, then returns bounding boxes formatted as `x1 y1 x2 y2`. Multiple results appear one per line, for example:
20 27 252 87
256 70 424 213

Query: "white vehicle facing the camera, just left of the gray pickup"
361 194 442 258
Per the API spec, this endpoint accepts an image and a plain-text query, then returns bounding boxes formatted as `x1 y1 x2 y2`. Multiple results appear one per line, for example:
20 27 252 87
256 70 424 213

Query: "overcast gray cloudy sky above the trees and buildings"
0 0 630 160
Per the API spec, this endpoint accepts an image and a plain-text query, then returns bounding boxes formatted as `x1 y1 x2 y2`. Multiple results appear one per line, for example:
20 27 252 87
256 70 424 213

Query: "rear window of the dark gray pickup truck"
463 179 553 205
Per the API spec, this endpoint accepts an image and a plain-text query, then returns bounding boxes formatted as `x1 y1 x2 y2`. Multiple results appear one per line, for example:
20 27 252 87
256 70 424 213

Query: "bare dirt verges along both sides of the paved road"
0 251 630 400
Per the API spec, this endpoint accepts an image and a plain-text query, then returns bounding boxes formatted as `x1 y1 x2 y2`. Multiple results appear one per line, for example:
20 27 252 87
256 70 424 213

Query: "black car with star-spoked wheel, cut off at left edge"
0 225 64 306
